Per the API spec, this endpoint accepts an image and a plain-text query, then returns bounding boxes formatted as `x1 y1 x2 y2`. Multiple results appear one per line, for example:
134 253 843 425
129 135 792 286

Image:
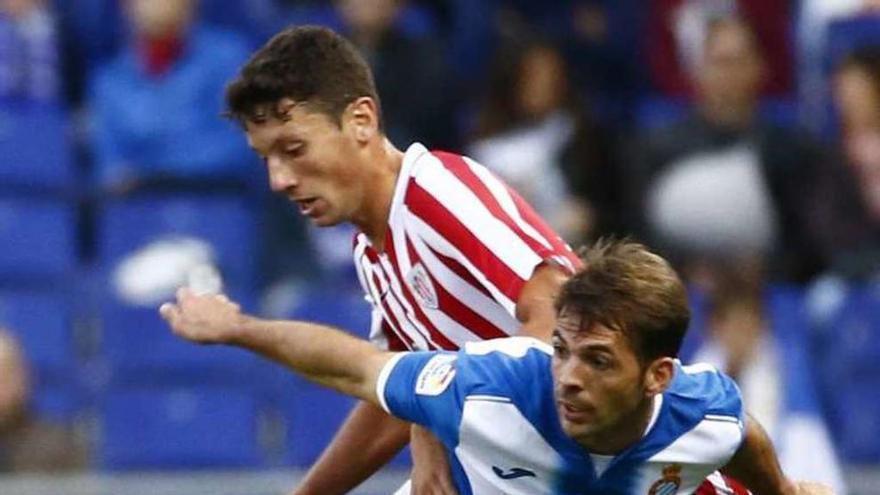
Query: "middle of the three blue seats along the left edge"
0 198 76 283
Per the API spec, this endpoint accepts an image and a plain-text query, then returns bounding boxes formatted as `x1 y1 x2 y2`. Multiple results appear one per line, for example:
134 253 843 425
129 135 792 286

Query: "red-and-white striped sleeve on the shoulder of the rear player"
404 152 580 314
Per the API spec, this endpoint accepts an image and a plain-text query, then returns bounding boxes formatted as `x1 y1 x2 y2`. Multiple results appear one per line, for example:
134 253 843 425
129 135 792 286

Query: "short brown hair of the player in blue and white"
556 239 690 364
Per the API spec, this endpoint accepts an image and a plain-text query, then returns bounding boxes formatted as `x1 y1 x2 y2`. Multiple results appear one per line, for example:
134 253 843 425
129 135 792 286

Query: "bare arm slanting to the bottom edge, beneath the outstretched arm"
294 403 410 495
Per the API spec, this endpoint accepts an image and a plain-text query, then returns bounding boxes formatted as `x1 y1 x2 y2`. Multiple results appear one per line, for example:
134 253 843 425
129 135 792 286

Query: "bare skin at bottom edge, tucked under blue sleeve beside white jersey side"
410 425 458 495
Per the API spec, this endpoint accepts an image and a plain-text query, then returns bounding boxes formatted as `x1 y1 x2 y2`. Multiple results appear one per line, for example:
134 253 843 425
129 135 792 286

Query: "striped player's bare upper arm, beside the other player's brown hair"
516 264 568 342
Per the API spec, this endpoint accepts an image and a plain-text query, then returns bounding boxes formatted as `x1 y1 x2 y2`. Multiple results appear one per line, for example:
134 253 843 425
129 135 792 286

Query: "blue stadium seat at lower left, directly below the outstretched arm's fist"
97 388 264 470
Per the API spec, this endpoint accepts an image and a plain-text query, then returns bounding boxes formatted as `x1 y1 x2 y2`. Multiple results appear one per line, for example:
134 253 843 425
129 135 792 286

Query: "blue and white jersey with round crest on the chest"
377 337 743 495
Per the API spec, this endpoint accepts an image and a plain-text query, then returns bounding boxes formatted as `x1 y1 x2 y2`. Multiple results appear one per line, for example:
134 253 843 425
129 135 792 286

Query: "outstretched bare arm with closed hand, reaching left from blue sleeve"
159 289 393 404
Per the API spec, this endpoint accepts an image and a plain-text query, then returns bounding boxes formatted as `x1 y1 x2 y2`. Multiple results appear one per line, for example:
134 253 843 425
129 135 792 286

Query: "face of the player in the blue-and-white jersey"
552 313 647 453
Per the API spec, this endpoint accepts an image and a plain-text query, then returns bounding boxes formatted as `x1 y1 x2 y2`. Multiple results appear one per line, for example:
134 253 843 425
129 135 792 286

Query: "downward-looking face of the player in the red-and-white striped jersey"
246 98 368 227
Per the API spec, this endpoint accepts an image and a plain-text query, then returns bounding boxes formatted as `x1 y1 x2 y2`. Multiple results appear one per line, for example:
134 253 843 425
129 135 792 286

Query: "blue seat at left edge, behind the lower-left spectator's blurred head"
0 289 83 421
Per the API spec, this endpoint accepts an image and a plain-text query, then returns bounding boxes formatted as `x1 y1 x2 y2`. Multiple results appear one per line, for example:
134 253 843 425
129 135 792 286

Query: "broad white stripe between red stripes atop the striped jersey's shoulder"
416 159 541 280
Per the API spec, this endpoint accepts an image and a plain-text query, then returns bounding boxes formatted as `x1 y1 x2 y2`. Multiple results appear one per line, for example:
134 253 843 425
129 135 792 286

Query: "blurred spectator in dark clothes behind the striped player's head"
336 0 456 148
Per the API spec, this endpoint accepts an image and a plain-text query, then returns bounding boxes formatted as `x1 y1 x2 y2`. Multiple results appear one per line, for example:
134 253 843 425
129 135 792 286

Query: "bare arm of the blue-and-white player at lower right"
721 416 798 495
